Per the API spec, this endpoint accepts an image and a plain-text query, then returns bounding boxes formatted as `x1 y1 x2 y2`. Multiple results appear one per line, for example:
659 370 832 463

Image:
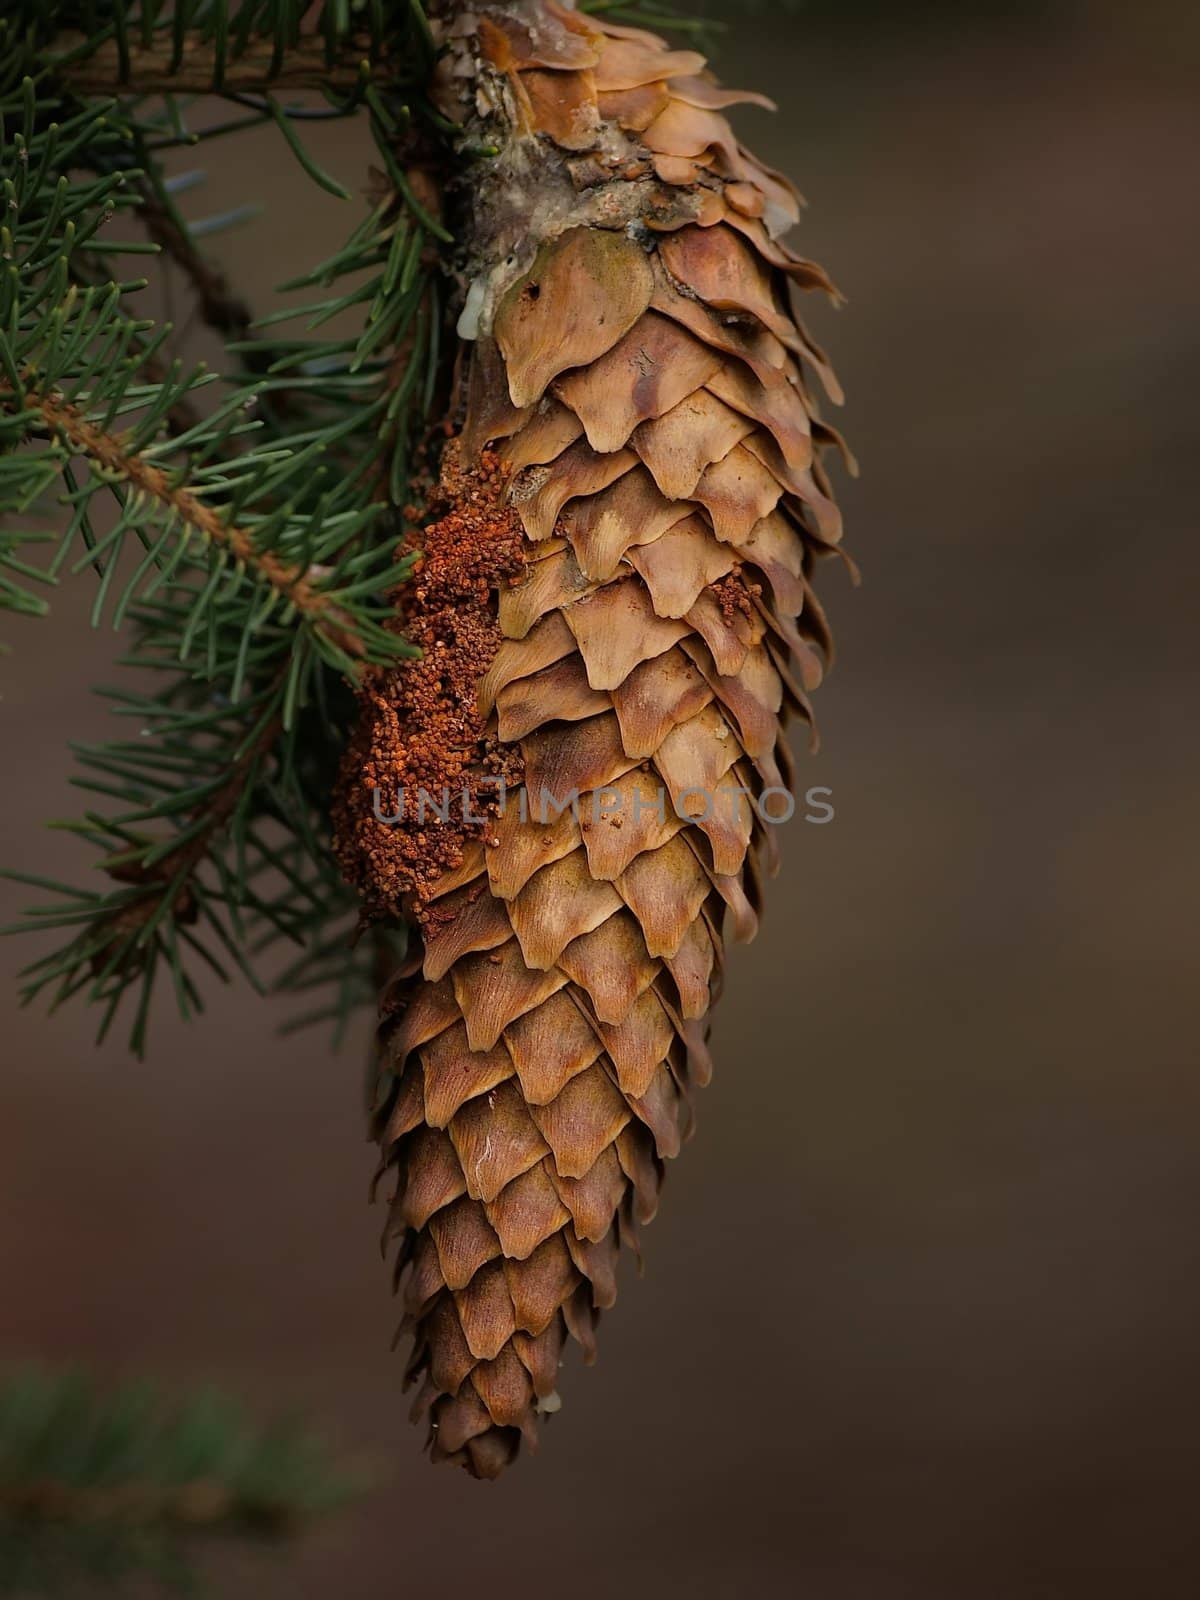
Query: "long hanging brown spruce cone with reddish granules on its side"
338 0 840 1477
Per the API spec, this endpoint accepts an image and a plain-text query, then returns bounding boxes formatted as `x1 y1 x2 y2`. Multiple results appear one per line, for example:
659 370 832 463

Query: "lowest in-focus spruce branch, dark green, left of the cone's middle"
3 643 341 1054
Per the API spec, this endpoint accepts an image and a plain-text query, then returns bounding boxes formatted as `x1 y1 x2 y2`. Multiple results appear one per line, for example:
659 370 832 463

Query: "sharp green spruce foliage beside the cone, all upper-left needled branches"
0 0 448 1053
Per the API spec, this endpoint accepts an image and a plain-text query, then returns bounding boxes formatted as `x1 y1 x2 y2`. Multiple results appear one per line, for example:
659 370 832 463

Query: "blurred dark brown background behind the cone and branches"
0 3 1200 1600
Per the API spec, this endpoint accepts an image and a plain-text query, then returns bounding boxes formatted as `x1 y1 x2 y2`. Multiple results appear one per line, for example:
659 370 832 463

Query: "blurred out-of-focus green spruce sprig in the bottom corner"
0 1368 365 1595
